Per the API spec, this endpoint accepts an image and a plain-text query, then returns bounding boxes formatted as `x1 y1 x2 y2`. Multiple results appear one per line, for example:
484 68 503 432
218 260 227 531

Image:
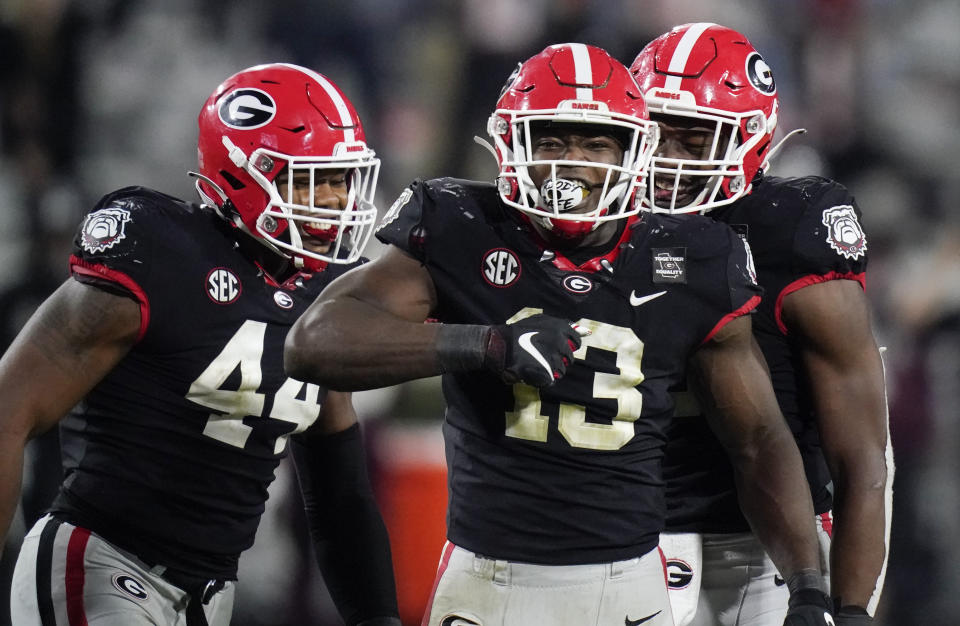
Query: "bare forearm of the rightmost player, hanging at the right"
830 468 890 608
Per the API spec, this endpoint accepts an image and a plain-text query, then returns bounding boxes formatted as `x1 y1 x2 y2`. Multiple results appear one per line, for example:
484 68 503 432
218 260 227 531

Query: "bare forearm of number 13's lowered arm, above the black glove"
736 428 821 577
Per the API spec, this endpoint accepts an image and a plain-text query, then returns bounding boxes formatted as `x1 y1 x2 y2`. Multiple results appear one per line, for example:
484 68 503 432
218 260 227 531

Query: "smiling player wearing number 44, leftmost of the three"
0 64 400 626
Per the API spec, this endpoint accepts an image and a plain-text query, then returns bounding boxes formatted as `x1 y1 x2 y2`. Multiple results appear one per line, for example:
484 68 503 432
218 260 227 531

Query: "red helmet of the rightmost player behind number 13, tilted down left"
630 23 779 213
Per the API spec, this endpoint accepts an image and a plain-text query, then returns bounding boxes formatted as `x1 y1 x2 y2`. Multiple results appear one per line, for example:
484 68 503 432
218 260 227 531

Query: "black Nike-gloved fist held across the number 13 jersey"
484 313 590 387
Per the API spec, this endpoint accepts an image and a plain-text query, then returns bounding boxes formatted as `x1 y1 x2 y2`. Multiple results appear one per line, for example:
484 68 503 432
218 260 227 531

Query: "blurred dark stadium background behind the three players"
0 0 960 626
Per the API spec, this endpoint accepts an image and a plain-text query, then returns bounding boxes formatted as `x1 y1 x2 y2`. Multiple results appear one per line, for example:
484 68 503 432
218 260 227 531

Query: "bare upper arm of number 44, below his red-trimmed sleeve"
0 279 140 434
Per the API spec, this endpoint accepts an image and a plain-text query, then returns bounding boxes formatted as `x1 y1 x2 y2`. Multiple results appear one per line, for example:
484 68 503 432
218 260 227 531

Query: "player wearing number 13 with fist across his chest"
285 43 829 626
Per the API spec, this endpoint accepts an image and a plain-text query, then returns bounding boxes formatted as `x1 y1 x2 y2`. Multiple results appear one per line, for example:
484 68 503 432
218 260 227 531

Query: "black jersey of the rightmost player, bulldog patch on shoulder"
664 177 867 532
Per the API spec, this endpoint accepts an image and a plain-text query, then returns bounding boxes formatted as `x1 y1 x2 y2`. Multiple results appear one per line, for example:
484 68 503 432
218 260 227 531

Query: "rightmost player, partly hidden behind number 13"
631 23 893 626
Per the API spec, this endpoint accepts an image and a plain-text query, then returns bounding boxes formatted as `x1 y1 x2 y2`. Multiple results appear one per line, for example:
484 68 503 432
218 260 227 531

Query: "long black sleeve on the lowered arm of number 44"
291 424 399 626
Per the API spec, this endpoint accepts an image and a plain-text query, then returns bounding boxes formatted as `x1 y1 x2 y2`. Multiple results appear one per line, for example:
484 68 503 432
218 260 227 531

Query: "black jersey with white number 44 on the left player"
47 188 360 578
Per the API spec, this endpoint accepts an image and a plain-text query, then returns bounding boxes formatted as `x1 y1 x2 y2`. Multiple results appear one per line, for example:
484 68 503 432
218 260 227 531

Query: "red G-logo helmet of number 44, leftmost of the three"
197 63 380 271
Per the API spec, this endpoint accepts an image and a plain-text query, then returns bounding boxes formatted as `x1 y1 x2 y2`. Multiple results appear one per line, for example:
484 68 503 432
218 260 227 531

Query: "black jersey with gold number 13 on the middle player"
378 179 759 564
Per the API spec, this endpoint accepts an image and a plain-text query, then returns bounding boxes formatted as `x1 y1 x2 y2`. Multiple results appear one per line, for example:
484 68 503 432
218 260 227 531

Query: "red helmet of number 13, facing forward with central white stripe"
487 43 658 238
